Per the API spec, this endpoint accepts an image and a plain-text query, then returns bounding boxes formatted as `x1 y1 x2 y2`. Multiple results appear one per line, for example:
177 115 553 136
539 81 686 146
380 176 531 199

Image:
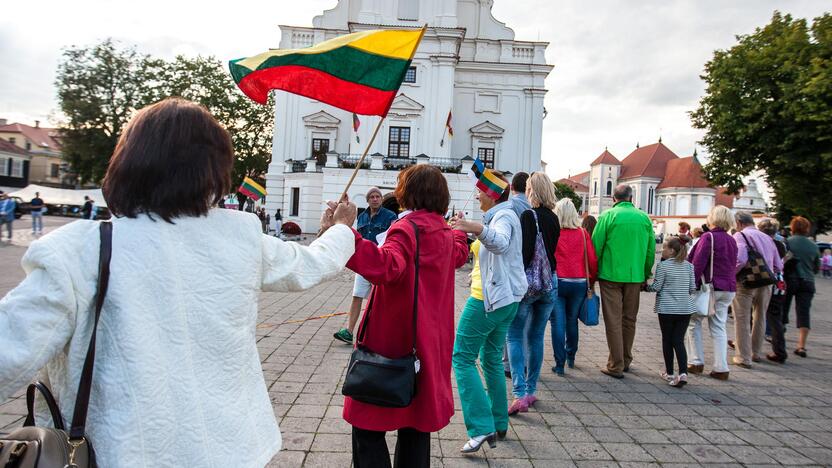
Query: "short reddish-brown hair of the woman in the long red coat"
393 164 451 216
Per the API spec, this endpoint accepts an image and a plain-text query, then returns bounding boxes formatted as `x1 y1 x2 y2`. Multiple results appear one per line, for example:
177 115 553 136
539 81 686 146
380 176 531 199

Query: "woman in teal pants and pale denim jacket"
451 169 528 453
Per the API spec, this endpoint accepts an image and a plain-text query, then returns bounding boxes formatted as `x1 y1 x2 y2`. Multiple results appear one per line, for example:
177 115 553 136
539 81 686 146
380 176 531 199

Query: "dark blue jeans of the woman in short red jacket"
549 279 586 367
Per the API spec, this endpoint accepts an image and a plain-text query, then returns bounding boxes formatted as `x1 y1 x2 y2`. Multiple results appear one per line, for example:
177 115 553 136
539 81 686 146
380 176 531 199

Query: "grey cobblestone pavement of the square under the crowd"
0 218 832 467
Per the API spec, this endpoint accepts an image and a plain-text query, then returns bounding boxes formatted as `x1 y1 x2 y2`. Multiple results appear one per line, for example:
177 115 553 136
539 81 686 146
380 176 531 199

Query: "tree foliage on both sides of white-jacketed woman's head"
55 39 274 186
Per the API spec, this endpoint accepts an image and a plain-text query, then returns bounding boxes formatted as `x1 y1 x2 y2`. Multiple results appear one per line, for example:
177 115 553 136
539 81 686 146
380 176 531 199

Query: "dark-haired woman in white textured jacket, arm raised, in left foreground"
0 99 355 468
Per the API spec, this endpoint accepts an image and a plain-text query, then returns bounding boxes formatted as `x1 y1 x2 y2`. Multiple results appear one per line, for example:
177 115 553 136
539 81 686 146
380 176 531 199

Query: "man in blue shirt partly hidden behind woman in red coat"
333 187 397 344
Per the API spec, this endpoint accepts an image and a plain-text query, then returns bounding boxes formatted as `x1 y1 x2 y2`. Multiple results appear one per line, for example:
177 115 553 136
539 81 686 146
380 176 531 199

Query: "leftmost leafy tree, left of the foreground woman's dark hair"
55 39 162 182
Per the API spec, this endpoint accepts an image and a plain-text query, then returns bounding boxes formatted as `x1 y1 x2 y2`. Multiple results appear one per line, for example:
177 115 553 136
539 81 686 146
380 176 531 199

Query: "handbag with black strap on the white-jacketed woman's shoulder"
0 221 113 468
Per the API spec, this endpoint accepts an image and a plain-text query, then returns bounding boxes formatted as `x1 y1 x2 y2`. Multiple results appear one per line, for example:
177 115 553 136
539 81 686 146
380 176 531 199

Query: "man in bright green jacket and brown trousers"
592 184 656 379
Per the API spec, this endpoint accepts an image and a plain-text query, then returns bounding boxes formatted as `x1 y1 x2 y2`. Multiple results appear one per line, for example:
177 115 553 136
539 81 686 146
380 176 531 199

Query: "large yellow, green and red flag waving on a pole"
229 29 424 117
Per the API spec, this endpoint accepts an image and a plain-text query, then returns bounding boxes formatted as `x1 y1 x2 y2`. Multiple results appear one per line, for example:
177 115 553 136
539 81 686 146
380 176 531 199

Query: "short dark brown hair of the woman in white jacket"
102 98 234 223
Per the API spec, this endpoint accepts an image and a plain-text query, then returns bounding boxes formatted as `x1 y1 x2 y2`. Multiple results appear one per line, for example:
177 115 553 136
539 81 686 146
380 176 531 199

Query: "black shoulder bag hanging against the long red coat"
341 220 419 408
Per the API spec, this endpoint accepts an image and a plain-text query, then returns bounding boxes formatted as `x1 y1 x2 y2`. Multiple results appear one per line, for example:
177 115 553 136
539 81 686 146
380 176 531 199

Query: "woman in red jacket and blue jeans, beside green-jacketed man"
549 198 598 375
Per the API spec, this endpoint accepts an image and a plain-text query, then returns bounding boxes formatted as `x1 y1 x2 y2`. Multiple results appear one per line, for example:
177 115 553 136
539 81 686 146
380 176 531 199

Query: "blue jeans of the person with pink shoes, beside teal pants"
507 283 558 398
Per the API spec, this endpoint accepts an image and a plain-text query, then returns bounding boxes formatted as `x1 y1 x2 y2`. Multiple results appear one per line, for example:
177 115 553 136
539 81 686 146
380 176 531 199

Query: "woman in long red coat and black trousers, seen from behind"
344 165 468 468
